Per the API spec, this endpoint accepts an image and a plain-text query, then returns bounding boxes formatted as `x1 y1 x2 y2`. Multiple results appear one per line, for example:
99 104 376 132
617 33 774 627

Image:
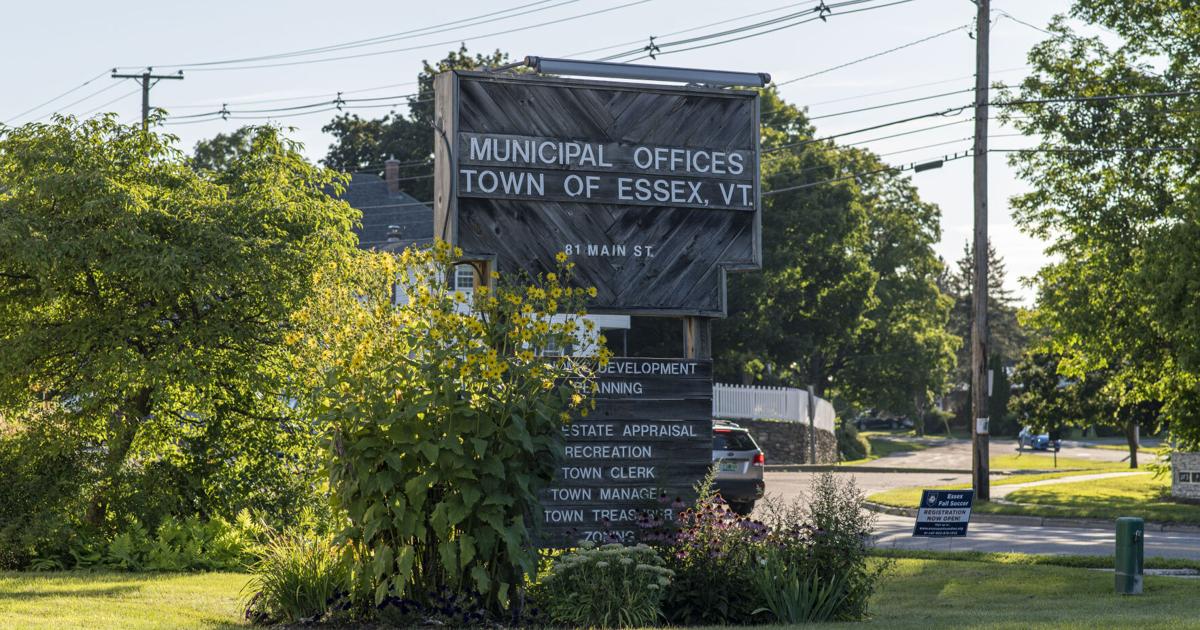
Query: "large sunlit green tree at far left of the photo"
0 116 356 526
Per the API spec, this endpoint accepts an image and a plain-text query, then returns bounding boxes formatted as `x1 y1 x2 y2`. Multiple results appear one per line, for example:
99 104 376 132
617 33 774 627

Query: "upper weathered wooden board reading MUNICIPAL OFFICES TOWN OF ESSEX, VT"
434 72 762 317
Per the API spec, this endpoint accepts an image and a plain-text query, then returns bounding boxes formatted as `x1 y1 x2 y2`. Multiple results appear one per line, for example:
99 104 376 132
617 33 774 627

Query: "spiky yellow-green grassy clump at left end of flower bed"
244 533 350 623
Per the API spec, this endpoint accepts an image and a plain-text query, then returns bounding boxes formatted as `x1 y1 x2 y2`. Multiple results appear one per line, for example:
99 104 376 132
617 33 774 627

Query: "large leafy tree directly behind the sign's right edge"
714 90 953 413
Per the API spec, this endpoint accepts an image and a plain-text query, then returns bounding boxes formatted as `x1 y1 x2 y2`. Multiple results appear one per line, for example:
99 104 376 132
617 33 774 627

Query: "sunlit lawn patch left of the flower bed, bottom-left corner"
0 571 248 630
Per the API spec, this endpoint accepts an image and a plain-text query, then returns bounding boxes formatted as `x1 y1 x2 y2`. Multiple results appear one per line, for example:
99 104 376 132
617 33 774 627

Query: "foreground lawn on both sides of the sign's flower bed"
9 554 1200 630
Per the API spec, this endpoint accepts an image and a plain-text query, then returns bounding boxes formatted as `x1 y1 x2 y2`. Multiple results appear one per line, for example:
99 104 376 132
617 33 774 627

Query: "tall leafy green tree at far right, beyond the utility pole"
1006 0 1200 448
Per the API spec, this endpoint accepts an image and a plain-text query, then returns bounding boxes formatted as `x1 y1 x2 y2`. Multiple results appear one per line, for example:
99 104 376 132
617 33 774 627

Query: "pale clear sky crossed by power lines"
0 0 1069 304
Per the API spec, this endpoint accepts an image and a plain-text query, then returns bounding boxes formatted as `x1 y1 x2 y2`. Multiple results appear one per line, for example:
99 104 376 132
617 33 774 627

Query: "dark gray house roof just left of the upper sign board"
342 173 433 250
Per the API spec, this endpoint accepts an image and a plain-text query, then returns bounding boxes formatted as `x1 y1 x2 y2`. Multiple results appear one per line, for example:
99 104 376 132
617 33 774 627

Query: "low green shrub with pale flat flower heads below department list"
535 544 673 628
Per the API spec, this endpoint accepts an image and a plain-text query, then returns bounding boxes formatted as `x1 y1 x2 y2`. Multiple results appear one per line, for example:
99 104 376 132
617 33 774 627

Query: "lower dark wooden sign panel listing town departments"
534 358 713 546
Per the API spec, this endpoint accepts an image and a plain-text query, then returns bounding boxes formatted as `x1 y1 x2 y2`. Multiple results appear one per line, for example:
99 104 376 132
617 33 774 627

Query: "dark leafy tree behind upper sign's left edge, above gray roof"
322 46 509 200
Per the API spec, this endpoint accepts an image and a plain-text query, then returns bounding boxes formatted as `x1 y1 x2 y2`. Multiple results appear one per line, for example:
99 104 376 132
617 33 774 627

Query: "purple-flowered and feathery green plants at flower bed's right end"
664 473 888 625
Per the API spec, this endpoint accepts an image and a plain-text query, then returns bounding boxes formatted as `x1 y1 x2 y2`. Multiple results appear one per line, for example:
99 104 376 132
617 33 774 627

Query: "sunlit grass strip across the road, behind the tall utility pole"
868 472 1200 520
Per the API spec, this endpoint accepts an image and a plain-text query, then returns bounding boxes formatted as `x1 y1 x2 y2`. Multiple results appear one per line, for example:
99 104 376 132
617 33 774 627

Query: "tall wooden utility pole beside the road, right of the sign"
971 0 991 502
